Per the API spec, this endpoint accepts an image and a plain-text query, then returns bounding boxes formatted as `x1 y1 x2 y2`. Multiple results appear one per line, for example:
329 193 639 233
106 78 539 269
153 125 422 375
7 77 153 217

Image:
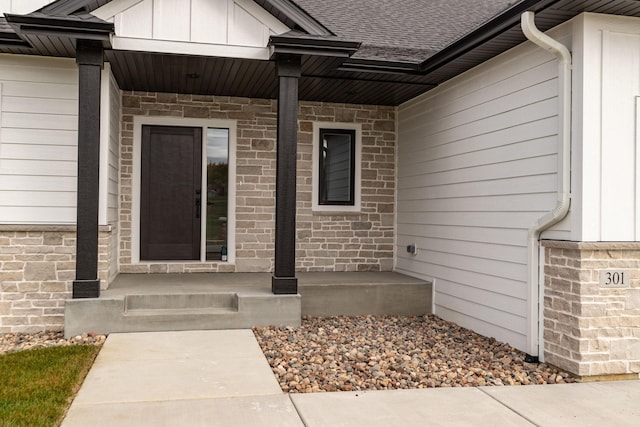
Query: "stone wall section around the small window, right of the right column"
296 102 396 271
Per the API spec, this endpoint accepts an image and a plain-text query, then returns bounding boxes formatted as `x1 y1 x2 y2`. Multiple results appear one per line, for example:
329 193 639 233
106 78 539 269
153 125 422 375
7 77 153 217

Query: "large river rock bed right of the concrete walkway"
253 315 576 393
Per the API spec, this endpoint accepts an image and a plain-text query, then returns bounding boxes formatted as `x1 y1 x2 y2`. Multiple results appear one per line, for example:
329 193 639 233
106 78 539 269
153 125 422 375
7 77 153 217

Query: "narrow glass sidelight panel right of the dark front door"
207 128 229 261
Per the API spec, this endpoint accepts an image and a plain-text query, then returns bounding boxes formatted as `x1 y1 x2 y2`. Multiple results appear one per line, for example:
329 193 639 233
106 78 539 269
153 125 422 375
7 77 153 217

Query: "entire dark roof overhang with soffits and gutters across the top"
0 0 640 105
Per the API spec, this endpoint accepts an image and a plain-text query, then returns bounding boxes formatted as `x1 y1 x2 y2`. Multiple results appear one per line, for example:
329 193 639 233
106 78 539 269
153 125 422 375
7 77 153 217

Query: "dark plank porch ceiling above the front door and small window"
106 51 434 105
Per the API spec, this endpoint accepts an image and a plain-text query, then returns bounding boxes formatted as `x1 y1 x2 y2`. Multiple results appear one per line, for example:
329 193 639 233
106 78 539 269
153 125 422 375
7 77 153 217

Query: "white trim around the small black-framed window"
311 122 362 212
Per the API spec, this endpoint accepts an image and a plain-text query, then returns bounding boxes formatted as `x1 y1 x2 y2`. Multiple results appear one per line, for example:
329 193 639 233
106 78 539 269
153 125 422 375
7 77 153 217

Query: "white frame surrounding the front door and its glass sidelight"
131 116 237 264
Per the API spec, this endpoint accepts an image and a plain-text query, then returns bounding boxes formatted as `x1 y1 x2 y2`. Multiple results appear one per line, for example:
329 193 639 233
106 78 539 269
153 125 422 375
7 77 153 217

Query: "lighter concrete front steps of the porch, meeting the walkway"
64 291 301 337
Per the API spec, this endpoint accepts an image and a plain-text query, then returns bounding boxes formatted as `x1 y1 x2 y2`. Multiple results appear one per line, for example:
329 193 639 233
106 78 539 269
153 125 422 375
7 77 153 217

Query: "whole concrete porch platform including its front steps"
65 272 432 336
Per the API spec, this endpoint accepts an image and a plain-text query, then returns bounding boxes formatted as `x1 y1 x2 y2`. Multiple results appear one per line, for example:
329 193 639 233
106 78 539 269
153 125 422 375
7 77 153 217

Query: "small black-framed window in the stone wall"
318 129 356 206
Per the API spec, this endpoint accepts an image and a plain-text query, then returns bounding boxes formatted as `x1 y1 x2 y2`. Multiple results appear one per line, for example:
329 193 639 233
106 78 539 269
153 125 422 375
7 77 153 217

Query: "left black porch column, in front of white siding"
73 40 103 298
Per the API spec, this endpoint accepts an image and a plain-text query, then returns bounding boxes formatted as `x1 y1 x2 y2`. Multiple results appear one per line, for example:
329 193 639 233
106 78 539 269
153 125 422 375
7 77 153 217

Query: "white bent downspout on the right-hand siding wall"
521 11 571 358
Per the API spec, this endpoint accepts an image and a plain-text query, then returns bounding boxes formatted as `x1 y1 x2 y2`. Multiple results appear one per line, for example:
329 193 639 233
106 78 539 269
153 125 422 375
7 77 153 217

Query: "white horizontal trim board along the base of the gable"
111 36 269 61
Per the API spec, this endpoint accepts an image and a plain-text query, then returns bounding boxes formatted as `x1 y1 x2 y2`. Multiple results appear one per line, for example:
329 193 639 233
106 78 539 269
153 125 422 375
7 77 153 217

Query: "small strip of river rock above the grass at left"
0 331 106 354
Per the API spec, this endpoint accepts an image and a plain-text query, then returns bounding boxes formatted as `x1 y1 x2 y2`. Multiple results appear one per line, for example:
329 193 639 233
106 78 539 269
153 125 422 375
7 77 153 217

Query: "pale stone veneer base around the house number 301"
542 241 640 376
